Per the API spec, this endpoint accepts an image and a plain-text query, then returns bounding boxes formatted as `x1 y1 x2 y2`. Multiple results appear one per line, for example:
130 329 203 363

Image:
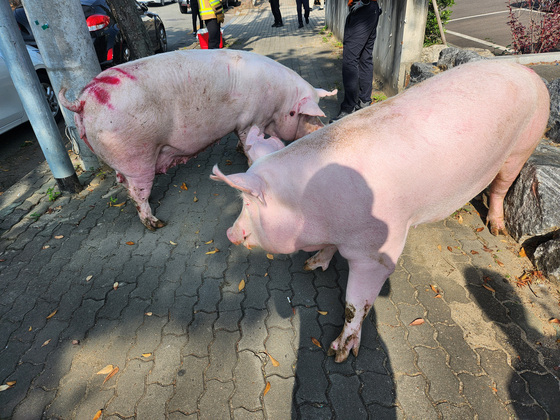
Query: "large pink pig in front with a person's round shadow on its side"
212 61 549 362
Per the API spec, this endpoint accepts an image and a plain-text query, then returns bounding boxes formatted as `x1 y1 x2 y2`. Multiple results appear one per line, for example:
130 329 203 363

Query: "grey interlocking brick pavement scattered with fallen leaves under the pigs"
0 1 560 420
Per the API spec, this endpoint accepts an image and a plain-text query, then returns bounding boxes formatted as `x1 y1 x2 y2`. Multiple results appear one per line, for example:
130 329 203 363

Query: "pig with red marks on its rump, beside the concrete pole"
59 50 336 230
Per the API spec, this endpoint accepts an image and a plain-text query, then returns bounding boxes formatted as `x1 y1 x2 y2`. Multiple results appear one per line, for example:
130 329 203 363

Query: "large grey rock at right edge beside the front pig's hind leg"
504 141 560 242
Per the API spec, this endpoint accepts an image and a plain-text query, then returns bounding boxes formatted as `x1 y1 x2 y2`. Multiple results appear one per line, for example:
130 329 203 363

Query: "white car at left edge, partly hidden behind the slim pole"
0 45 62 134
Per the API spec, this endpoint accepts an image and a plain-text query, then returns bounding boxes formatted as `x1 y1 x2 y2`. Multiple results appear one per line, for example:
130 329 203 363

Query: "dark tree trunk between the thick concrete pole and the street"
107 0 154 60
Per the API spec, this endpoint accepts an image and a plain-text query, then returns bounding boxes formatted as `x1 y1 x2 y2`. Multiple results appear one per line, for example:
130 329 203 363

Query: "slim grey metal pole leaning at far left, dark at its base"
0 0 82 193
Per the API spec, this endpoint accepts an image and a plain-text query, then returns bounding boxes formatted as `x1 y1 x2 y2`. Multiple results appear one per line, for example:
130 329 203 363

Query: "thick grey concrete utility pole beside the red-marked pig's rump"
21 0 101 171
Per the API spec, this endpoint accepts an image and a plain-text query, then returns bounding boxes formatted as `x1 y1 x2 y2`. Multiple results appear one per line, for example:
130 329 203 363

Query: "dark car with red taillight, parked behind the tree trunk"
14 0 167 67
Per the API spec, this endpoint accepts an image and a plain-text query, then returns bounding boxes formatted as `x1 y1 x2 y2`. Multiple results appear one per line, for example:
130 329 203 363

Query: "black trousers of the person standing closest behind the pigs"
340 0 380 113
